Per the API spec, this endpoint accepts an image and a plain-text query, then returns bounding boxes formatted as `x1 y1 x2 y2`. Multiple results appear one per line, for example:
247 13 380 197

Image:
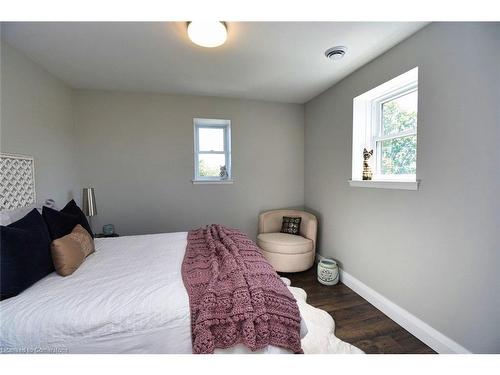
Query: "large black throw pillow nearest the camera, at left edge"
0 208 54 299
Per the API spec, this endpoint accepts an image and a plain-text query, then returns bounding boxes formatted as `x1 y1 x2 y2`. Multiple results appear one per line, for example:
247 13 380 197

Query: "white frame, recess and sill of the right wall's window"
349 67 419 190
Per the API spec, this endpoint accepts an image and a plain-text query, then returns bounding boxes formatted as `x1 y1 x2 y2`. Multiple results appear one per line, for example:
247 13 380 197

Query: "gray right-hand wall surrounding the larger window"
305 23 500 352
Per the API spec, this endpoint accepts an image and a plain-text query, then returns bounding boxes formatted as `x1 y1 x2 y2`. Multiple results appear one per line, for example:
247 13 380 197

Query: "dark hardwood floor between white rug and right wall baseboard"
281 267 435 354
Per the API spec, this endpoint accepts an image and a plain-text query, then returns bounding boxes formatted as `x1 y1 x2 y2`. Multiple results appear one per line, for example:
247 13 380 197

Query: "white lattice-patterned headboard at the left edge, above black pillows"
0 153 36 211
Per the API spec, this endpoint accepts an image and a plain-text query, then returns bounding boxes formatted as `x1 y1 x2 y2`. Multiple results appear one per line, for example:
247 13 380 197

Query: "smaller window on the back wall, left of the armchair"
194 118 231 182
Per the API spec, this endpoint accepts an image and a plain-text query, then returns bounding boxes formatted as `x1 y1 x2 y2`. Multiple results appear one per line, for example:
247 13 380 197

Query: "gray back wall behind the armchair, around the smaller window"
74 91 304 236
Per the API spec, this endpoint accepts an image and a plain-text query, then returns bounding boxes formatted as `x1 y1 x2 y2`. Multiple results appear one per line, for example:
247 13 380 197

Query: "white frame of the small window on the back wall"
192 118 233 183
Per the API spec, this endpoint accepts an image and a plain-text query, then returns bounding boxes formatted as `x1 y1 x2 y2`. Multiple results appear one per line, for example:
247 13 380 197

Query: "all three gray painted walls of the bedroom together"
0 24 500 352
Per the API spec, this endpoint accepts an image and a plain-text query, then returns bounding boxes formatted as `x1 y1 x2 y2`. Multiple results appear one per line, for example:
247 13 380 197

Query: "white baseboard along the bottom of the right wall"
340 270 471 354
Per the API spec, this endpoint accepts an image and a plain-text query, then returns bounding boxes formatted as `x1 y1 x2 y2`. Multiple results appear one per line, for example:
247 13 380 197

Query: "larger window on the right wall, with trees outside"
352 68 418 188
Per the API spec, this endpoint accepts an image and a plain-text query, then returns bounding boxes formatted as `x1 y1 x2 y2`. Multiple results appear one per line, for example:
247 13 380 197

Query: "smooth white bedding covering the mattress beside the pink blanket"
0 232 296 353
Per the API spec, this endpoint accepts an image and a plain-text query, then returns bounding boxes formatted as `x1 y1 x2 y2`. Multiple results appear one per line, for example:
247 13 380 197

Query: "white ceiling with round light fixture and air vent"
2 22 426 103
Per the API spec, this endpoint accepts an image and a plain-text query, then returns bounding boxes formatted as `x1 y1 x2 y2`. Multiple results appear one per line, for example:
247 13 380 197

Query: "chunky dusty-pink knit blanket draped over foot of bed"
182 225 302 353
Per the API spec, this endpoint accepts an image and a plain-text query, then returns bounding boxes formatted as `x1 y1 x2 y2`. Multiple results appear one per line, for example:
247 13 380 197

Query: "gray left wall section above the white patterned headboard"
0 42 80 204
